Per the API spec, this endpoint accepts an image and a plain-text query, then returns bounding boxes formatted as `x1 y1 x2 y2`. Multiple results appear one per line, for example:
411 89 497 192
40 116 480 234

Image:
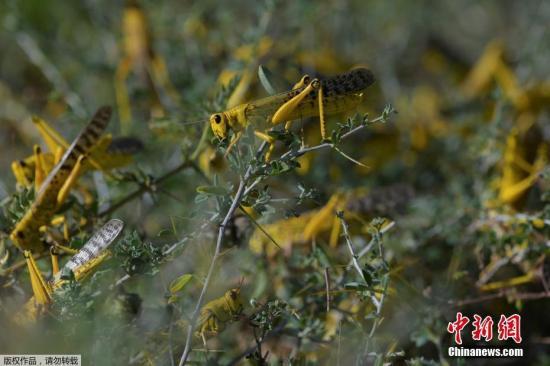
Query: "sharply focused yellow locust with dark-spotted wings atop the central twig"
210 68 374 159
